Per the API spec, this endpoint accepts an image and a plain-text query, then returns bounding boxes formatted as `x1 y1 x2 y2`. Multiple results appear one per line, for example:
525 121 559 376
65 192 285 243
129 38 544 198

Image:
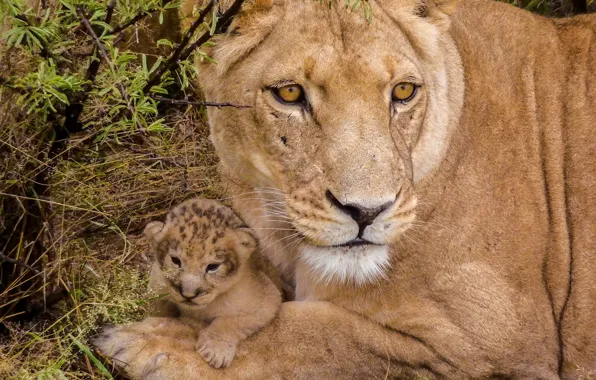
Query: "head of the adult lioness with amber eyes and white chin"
201 1 464 282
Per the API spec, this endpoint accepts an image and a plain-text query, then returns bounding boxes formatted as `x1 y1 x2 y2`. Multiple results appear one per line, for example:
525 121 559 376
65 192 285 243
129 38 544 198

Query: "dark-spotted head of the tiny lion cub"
144 199 257 307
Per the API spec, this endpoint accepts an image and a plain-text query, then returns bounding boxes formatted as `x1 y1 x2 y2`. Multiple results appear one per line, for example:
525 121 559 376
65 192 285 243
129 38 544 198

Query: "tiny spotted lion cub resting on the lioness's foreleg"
144 198 282 368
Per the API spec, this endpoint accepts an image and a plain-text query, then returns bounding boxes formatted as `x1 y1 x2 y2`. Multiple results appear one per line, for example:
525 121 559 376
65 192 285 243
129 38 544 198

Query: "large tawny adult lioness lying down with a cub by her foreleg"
94 0 596 379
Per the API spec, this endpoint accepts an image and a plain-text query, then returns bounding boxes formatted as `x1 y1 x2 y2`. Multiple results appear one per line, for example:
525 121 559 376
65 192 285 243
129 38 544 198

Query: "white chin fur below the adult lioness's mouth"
300 245 389 285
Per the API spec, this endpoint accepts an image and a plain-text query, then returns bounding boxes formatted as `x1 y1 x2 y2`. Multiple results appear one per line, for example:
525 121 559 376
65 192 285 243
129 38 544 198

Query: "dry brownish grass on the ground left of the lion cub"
0 91 220 379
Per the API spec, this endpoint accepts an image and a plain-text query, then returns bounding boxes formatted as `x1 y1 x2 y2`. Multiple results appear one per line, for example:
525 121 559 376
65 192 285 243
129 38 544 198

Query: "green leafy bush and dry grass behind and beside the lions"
0 0 594 379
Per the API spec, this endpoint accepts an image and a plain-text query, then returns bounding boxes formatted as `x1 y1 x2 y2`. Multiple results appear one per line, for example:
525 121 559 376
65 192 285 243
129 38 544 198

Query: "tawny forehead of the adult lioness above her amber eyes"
230 1 417 99
